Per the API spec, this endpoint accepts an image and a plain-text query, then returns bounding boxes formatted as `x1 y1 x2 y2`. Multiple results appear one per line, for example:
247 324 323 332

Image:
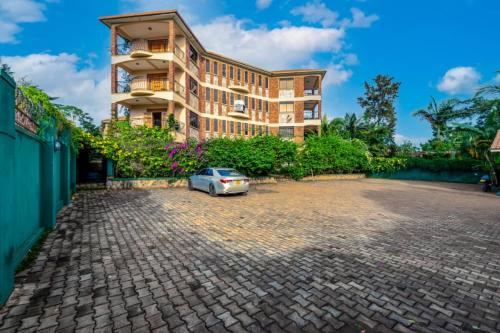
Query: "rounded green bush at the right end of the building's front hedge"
289 135 369 178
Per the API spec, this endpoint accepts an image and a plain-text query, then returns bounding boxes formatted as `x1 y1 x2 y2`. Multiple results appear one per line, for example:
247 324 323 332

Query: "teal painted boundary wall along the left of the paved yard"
0 70 76 305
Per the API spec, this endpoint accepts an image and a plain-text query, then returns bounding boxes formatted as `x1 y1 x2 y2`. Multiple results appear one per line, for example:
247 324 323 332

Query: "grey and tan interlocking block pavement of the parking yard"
0 179 500 333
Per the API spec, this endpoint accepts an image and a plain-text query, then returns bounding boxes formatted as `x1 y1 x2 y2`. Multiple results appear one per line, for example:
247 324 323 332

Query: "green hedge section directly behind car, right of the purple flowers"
204 136 297 176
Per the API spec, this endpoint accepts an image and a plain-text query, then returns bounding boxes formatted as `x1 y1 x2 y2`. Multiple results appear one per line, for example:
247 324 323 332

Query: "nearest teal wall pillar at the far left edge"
0 69 16 305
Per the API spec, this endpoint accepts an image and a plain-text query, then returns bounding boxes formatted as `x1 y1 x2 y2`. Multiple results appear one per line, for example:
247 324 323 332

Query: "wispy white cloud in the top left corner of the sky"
0 0 46 43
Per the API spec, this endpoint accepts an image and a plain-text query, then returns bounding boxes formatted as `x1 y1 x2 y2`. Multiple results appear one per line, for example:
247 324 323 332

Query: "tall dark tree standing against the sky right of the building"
358 75 401 142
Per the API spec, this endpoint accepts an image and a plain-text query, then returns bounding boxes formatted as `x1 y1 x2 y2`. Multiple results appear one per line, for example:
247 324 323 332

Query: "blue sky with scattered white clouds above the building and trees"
0 0 500 142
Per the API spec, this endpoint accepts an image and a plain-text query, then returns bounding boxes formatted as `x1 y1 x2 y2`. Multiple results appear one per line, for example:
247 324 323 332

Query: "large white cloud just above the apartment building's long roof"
192 16 345 69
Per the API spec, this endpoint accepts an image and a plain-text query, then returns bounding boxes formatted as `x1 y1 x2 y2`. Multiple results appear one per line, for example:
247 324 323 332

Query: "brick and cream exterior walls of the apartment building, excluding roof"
106 13 321 142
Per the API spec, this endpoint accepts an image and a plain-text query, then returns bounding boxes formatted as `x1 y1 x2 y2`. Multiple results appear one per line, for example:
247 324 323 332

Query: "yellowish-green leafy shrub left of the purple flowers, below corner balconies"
86 122 174 178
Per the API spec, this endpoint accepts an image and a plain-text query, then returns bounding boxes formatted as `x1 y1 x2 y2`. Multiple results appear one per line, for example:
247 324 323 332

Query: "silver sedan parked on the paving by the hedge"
188 168 250 196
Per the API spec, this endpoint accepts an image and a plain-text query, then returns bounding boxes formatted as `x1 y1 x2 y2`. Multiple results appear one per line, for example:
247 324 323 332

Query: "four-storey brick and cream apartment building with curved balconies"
100 10 326 142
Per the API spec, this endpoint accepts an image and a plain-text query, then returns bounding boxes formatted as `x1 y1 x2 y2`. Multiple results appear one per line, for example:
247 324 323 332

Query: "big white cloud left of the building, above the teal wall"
2 53 111 122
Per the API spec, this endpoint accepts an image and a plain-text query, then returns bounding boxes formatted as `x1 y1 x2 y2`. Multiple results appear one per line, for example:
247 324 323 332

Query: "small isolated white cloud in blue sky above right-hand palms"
437 67 481 95
